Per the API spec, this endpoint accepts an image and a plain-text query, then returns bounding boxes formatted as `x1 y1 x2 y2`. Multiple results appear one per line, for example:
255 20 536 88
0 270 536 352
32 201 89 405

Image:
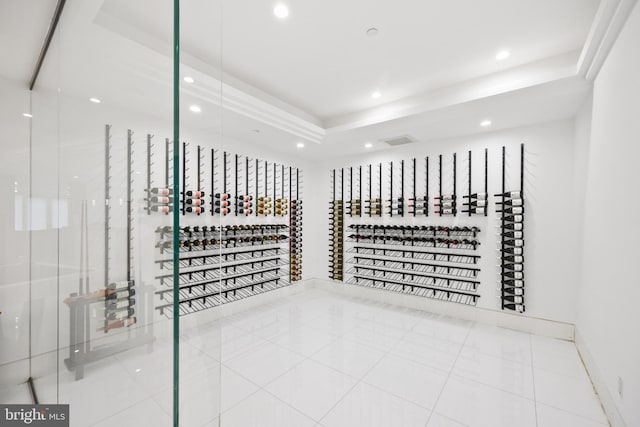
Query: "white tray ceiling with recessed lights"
0 0 611 158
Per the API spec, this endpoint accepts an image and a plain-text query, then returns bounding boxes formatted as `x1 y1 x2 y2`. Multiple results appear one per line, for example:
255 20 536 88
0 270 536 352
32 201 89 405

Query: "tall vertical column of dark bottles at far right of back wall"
495 144 525 313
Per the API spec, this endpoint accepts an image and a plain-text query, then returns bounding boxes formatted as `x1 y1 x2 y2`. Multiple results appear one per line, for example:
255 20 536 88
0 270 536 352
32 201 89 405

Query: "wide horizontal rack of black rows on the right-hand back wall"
346 224 480 305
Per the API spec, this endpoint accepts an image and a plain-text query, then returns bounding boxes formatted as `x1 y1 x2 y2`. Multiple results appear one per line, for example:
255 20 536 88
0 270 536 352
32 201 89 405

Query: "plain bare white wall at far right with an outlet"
576 1 640 426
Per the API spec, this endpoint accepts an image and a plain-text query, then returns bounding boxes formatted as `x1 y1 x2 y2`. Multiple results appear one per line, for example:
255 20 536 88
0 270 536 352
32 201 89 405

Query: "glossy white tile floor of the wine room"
5 290 608 427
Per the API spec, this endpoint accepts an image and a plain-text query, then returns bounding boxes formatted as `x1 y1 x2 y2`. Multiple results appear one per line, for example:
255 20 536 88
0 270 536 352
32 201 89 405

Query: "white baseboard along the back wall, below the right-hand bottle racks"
313 279 575 341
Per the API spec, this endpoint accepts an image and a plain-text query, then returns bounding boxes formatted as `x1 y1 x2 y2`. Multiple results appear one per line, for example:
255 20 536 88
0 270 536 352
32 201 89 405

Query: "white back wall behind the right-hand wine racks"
308 120 581 323
